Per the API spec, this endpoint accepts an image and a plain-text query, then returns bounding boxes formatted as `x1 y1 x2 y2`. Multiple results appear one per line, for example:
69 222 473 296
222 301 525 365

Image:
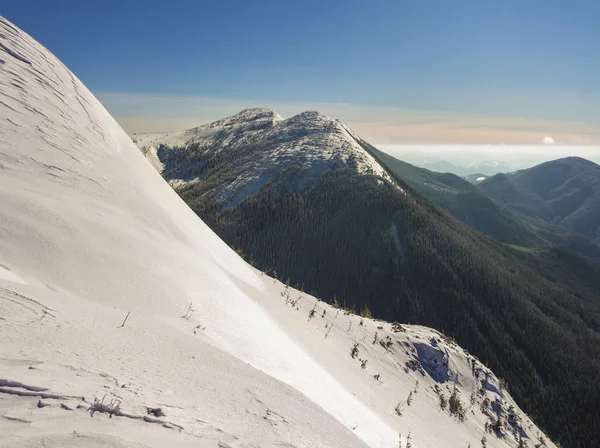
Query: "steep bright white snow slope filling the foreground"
0 18 550 448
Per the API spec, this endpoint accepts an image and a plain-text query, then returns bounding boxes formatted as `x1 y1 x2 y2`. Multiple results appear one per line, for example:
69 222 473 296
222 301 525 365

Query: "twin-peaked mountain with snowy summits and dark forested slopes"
133 109 600 446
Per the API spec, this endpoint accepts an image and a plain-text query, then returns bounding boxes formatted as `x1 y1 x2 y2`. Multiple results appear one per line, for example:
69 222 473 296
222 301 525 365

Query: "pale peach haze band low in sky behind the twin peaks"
97 93 600 145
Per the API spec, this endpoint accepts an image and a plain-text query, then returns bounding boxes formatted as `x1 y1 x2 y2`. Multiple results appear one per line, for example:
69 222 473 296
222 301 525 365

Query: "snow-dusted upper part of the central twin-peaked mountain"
133 109 391 206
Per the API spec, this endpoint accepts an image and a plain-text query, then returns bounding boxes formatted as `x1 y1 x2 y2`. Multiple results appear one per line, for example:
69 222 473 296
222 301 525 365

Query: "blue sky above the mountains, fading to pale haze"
0 0 600 143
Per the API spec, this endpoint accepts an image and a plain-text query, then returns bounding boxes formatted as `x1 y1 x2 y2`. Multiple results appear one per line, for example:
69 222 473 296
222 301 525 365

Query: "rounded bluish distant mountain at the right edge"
478 157 600 241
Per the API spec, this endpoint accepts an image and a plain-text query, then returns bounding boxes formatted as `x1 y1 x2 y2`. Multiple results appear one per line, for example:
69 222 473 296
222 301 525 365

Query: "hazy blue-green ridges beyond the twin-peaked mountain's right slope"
371 148 600 262
